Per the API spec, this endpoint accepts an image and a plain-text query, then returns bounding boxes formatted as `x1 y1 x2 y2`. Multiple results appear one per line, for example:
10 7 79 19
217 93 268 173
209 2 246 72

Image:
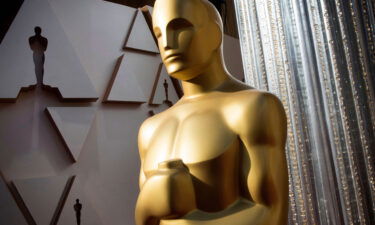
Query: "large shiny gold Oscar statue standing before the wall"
135 0 288 225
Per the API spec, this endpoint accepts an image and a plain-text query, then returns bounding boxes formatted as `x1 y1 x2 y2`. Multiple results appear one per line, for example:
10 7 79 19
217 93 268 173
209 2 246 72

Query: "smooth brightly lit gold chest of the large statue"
144 110 237 170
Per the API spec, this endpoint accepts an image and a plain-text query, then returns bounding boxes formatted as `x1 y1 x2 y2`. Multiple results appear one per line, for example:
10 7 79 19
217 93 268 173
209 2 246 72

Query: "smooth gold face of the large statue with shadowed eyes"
153 0 221 80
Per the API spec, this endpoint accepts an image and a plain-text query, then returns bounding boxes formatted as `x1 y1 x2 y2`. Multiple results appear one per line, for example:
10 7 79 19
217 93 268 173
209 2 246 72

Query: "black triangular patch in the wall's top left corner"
0 0 23 44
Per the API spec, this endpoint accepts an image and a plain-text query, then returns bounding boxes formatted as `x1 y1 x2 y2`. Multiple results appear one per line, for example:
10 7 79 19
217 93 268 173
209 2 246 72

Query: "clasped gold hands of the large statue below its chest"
136 159 196 225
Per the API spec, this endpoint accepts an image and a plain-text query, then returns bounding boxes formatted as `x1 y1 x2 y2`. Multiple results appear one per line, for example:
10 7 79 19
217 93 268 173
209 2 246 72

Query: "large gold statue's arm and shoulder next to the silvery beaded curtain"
239 93 288 225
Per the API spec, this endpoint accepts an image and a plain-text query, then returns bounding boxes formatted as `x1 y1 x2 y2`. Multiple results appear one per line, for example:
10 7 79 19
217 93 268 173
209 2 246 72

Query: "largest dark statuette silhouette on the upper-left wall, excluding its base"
29 26 48 86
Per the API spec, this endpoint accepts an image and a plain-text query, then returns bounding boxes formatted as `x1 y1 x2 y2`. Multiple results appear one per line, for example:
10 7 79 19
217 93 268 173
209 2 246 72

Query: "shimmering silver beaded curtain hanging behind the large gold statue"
234 0 375 225
